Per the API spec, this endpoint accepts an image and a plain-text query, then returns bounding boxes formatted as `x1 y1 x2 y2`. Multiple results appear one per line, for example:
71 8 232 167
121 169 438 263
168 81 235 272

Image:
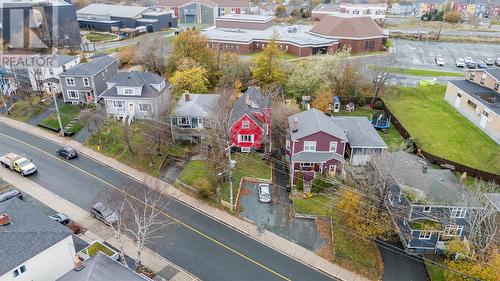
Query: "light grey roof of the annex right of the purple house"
333 116 387 148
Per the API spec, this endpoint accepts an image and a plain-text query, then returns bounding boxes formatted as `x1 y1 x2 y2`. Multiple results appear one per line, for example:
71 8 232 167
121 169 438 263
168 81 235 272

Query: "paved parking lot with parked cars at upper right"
393 39 500 71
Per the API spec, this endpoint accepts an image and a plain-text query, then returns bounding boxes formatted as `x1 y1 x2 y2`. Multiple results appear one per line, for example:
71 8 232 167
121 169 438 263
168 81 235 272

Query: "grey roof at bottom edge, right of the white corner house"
57 252 148 281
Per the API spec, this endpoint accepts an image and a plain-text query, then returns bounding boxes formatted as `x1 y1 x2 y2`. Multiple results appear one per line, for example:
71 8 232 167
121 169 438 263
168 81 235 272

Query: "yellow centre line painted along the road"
0 133 291 281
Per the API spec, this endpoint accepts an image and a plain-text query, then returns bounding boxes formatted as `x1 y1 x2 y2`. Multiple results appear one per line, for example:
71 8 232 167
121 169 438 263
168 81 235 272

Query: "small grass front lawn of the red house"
220 153 271 202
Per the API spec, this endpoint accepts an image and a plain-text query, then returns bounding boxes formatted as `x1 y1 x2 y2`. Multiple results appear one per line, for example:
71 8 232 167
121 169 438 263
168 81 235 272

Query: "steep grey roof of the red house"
229 87 271 126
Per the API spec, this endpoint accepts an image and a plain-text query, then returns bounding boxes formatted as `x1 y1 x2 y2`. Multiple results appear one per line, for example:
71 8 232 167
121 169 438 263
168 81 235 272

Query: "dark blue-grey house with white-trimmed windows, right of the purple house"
386 151 482 254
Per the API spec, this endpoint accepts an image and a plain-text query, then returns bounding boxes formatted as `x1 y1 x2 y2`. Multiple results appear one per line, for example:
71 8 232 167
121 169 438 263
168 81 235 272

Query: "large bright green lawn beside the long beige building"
383 85 500 174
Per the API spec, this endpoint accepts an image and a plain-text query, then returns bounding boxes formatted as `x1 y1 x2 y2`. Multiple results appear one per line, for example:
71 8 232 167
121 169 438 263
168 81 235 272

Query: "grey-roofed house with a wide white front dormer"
99 71 171 119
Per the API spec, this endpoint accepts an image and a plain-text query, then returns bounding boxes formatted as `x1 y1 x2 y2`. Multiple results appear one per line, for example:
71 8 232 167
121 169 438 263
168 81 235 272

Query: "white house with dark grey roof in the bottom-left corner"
0 198 75 281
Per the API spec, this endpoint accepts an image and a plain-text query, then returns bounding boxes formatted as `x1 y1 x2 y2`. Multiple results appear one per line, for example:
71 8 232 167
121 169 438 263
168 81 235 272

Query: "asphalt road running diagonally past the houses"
0 125 332 280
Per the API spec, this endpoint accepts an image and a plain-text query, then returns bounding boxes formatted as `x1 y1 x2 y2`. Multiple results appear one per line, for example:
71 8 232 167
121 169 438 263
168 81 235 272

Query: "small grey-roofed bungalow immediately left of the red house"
170 93 219 142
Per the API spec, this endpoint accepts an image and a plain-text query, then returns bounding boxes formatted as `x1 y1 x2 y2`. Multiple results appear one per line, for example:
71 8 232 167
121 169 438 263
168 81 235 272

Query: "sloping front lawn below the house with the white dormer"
86 122 167 177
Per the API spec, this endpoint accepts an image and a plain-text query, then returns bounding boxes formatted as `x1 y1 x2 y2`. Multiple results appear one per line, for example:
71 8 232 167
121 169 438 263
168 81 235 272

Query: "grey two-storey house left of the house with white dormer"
59 56 118 104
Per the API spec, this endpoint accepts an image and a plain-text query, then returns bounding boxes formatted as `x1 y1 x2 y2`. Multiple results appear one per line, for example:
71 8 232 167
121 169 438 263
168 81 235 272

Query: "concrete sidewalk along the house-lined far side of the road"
0 116 368 280
